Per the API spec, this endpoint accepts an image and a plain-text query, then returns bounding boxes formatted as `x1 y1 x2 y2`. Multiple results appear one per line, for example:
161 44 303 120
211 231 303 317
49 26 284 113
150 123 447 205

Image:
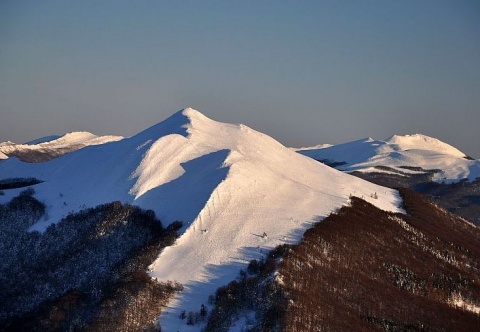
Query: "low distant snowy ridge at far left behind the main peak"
0 132 123 162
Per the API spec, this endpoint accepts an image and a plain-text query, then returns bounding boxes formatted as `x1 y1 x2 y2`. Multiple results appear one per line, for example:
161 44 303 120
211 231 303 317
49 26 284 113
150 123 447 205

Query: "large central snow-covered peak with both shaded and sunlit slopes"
0 108 400 330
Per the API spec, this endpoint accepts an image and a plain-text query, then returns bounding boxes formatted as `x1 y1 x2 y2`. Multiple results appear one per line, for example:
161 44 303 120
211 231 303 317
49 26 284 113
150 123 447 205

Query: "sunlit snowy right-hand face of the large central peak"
145 110 398 331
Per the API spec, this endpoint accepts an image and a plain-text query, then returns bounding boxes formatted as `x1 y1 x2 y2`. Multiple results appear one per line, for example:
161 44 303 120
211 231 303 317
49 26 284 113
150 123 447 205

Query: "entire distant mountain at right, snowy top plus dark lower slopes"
298 134 480 225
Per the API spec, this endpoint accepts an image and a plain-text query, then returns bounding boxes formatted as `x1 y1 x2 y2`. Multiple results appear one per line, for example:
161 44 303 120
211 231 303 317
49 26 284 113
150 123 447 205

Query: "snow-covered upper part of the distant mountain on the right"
298 134 480 182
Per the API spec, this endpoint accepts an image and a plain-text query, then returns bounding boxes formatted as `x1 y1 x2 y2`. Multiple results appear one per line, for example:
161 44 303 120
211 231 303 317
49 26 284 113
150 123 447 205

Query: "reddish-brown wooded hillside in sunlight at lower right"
277 190 480 331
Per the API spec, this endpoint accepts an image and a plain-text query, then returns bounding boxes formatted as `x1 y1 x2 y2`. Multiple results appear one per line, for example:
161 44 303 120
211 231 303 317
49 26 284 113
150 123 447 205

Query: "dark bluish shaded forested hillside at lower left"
0 188 181 332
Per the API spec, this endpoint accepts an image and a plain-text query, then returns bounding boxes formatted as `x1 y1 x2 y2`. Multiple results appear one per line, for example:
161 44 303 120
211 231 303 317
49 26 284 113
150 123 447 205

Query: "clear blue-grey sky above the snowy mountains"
0 0 480 158
